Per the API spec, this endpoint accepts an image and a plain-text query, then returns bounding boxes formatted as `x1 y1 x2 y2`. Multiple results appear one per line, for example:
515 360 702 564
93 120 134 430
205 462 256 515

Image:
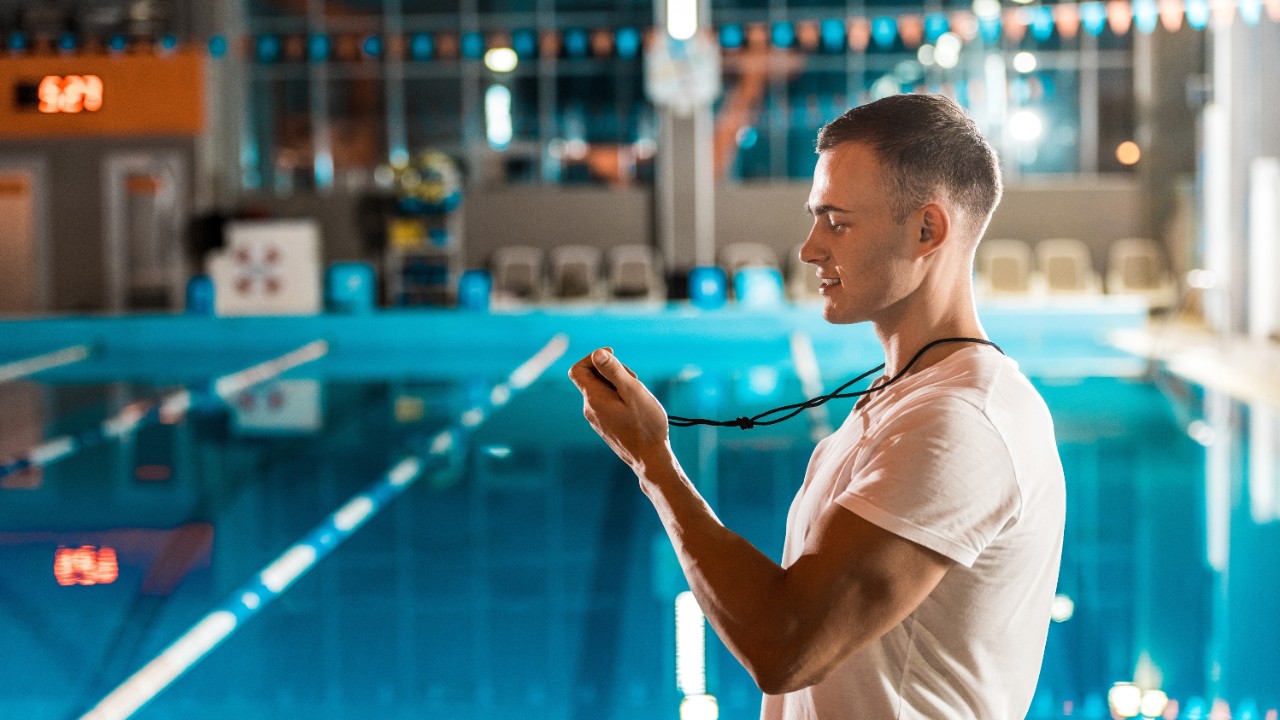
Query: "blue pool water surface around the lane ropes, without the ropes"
0 322 1280 720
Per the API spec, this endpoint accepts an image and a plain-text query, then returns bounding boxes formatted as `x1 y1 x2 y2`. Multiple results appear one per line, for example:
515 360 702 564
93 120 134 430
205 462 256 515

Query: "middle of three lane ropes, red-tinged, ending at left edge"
0 340 329 479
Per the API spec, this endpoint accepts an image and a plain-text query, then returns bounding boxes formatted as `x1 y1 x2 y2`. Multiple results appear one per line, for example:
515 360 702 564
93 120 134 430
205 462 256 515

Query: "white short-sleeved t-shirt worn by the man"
760 346 1066 720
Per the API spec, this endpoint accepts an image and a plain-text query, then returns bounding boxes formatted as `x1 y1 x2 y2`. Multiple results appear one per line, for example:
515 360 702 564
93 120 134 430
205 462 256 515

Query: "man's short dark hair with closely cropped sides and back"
818 95 1004 240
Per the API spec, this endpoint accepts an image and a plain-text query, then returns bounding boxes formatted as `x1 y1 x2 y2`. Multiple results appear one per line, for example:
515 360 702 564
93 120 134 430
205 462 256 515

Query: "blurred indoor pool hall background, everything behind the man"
0 0 1280 720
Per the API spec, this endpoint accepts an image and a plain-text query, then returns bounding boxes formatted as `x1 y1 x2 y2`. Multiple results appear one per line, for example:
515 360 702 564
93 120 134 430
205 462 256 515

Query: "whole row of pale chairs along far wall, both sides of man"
492 238 1178 307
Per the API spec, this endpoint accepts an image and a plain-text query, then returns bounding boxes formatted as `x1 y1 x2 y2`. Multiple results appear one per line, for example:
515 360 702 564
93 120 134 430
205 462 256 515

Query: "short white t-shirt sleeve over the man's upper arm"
836 396 1021 568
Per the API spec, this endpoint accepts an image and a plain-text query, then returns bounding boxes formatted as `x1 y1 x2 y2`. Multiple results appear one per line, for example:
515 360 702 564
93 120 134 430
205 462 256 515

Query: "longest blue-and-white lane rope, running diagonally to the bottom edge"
81 334 568 720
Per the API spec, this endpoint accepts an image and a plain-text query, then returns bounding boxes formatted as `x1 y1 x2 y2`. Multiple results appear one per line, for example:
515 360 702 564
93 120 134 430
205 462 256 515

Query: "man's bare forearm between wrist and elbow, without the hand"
634 448 797 688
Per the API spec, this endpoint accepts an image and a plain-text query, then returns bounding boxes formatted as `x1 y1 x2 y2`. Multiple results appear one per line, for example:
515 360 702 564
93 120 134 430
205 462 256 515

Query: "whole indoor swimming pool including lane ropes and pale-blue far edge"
0 299 1280 720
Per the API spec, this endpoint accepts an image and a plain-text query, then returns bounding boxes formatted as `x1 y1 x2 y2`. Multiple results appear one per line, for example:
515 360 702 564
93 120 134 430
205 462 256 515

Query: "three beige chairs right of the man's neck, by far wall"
977 237 1178 303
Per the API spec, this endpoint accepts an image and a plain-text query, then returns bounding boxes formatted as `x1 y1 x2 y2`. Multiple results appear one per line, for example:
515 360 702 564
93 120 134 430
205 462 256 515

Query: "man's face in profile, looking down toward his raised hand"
800 142 916 324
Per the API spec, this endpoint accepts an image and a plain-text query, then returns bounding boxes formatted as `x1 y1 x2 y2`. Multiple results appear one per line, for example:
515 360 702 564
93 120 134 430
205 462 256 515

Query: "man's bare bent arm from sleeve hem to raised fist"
570 351 951 694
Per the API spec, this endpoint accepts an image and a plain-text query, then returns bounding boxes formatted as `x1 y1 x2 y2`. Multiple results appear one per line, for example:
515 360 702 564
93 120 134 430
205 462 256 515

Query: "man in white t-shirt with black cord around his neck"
570 95 1065 720
